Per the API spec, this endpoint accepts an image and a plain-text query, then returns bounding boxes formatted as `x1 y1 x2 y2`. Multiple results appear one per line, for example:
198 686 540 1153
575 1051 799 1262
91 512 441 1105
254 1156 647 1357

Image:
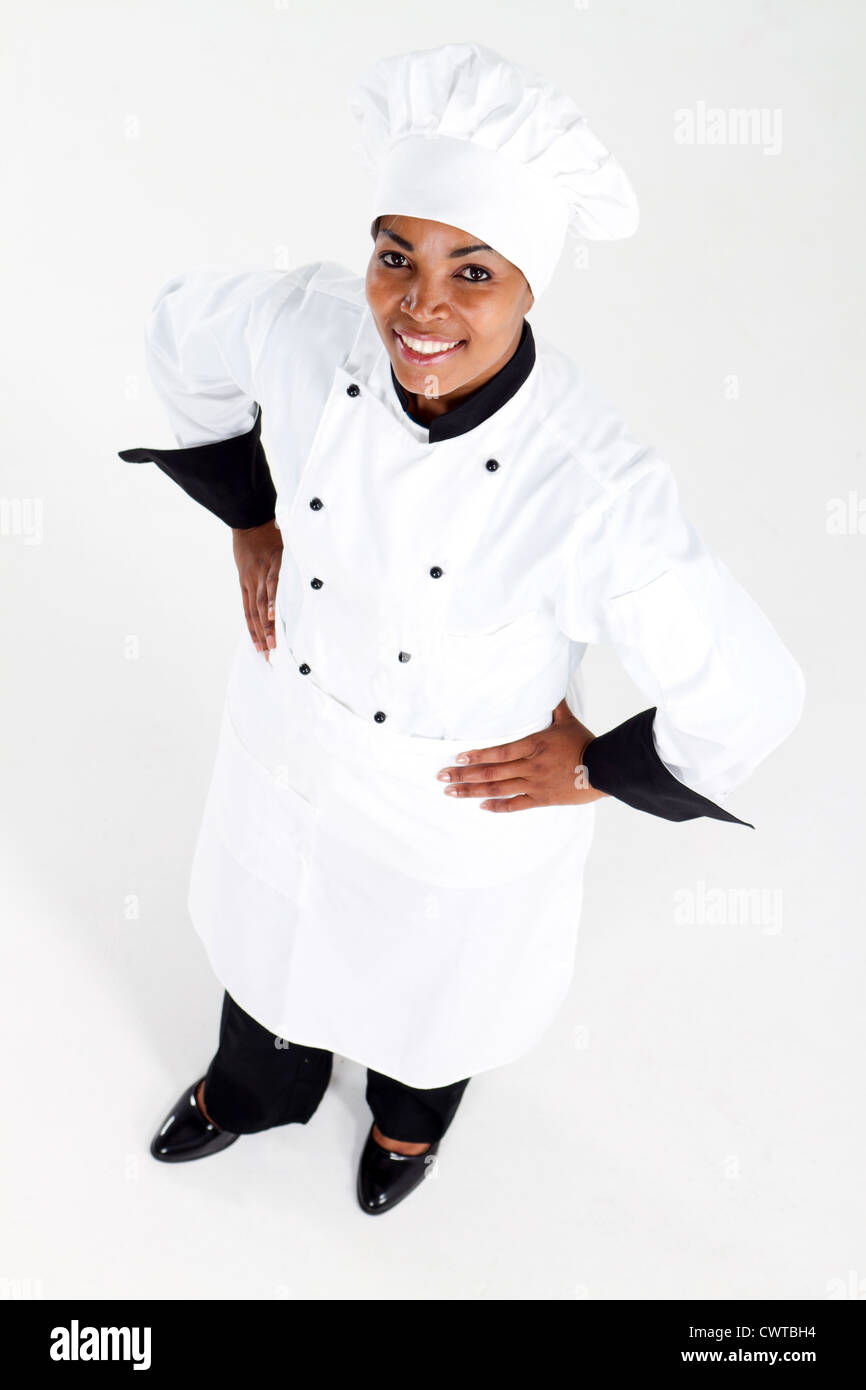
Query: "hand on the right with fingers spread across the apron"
436 696 607 810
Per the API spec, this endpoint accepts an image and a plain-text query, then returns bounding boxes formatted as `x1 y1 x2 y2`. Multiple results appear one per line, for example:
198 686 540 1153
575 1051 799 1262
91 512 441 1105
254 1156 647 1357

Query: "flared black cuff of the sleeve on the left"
118 406 277 528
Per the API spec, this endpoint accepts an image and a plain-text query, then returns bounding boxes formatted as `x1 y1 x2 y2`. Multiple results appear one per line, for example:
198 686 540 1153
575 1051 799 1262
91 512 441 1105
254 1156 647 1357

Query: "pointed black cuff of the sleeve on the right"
584 705 755 830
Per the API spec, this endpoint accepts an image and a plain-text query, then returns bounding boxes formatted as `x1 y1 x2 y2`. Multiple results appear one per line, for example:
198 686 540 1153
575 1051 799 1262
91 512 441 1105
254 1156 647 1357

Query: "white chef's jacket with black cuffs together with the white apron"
121 261 803 1087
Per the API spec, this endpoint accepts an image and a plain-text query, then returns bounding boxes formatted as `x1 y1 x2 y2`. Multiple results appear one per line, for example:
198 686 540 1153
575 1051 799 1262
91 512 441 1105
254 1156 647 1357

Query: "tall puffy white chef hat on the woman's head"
349 43 638 297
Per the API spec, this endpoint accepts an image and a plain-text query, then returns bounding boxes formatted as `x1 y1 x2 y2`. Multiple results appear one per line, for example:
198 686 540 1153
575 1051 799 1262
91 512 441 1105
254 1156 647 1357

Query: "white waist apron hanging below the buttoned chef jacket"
189 614 594 1087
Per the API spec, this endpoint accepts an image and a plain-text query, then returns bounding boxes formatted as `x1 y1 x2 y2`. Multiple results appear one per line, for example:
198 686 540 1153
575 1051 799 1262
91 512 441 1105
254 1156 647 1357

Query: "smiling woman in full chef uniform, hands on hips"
121 43 803 1213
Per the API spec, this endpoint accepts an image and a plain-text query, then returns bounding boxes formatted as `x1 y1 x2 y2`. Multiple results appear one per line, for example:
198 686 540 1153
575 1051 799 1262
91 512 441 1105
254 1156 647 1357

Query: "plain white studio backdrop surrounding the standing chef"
0 0 866 1300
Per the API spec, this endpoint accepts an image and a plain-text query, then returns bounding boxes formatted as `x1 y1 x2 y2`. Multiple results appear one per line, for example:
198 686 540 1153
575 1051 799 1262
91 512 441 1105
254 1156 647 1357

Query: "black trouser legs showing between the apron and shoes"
204 991 471 1144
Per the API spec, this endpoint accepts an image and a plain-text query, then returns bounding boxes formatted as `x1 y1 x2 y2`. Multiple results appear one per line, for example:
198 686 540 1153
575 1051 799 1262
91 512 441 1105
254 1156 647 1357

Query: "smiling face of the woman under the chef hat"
367 217 534 414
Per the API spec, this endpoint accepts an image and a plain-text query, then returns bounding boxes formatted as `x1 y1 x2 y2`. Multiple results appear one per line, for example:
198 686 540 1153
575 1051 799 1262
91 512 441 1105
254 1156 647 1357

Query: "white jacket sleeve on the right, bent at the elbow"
556 449 805 819
